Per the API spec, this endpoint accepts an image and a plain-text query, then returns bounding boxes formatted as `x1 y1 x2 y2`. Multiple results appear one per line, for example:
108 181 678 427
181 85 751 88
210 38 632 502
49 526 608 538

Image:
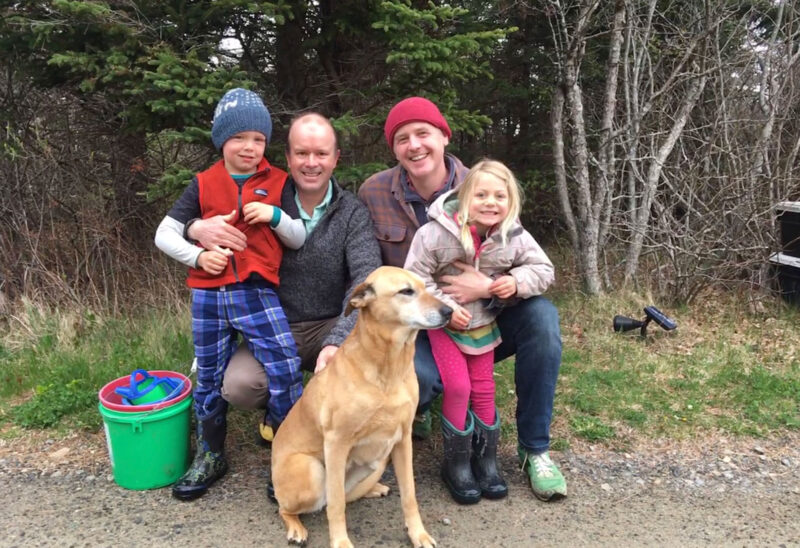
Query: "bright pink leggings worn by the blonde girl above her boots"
428 329 495 430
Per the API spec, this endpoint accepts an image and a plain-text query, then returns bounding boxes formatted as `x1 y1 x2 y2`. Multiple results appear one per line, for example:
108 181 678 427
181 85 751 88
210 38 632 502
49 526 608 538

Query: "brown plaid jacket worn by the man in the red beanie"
358 154 469 268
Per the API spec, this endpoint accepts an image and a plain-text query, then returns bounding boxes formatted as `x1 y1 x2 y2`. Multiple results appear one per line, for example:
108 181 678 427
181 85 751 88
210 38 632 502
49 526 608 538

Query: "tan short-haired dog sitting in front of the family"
272 266 453 548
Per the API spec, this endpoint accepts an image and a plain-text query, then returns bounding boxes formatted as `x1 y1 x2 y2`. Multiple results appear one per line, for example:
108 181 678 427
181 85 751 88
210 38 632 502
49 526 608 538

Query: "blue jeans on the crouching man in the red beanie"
414 297 561 453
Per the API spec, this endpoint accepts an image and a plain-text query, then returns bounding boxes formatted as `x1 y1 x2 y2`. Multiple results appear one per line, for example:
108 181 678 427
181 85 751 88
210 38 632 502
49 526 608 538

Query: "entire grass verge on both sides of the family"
0 294 800 450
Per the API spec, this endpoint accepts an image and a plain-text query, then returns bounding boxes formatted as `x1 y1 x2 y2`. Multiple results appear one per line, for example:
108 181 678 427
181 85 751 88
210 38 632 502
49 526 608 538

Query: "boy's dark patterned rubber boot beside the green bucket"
172 406 228 500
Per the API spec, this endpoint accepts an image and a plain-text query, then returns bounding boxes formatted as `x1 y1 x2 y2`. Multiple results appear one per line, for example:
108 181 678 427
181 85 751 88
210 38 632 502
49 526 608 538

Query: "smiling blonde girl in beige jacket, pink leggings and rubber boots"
405 160 553 504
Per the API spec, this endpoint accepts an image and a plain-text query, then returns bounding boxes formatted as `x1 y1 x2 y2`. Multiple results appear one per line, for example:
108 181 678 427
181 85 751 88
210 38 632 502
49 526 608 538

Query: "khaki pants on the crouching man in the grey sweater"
222 318 339 409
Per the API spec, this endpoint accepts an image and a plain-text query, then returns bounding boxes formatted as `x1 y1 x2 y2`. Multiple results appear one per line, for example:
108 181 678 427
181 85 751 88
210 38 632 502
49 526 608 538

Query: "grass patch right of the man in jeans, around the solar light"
554 297 800 444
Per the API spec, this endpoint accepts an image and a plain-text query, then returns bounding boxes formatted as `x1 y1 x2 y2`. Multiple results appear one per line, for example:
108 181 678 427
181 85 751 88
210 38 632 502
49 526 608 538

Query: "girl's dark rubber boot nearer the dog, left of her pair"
442 413 481 504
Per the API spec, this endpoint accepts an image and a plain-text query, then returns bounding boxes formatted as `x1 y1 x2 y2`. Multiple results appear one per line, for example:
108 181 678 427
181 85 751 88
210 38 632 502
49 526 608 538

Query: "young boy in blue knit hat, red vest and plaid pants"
155 88 305 500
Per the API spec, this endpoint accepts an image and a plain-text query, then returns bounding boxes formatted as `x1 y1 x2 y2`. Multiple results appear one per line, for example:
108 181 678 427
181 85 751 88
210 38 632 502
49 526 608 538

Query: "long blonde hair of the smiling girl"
457 159 522 256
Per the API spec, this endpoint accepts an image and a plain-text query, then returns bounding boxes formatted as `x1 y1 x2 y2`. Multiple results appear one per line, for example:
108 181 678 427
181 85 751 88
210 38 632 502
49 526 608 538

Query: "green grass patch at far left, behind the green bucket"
0 306 192 430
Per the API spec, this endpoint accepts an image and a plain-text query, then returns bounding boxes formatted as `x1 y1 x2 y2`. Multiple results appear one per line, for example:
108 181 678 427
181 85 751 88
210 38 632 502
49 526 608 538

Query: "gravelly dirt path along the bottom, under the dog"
0 435 800 548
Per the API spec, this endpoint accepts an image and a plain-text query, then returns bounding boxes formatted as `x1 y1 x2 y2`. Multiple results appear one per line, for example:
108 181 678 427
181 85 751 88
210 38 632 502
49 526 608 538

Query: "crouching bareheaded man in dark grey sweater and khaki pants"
186 113 381 432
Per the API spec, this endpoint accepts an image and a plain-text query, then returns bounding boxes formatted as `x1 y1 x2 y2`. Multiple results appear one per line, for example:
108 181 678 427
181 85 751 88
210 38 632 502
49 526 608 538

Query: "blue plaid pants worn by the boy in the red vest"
192 284 303 427
